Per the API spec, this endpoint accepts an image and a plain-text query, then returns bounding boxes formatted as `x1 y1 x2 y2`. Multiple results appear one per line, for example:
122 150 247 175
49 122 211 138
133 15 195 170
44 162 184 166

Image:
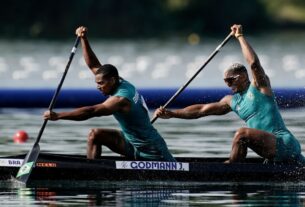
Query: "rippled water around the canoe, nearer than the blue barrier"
0 109 305 206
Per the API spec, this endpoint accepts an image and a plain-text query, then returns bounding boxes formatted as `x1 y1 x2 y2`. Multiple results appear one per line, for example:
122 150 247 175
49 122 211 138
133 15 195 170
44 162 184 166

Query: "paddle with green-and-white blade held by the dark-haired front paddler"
16 37 80 183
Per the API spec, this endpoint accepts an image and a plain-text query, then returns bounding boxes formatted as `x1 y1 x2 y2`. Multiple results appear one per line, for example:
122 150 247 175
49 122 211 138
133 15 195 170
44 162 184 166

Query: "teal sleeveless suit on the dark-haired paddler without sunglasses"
113 80 175 161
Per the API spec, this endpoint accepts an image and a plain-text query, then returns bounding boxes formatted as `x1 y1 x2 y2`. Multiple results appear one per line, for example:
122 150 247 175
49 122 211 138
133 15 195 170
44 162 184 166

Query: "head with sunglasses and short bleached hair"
224 63 250 93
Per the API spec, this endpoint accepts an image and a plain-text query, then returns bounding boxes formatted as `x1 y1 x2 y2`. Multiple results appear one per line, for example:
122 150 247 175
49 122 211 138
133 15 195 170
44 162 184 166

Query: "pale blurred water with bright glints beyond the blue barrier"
0 32 305 88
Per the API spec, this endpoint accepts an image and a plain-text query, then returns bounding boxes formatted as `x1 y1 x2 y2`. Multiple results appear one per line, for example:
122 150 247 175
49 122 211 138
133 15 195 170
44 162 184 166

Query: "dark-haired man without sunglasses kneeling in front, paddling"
44 26 175 162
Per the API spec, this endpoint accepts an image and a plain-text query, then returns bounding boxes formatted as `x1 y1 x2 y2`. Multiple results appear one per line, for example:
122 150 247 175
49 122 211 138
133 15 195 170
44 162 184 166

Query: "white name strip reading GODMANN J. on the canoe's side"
115 161 189 171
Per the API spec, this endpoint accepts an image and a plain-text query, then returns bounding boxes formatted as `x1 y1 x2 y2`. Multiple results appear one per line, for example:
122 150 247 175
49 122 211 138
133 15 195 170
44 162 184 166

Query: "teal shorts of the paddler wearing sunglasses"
275 133 305 164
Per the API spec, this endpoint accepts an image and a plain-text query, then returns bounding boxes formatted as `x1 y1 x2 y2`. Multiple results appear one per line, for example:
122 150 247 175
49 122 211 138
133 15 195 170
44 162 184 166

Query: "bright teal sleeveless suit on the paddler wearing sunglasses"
231 84 305 163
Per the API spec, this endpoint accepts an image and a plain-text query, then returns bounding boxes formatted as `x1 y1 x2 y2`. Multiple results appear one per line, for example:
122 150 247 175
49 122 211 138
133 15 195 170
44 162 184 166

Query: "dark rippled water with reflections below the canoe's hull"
0 182 305 206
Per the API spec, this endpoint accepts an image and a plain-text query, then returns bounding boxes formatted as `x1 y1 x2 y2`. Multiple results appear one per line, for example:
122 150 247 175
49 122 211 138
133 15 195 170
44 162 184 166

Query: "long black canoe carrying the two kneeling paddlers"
0 153 305 182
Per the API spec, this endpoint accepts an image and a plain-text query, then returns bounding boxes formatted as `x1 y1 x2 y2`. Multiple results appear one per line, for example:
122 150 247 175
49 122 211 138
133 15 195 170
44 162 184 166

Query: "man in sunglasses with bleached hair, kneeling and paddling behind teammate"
155 25 305 165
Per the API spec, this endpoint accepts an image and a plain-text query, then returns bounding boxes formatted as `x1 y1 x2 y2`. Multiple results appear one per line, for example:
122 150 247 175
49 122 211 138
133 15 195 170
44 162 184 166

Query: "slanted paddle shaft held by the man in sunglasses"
150 33 232 124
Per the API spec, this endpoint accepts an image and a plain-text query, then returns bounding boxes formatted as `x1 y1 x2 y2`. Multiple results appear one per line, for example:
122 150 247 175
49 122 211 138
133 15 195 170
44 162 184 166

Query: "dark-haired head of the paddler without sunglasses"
95 64 120 95
